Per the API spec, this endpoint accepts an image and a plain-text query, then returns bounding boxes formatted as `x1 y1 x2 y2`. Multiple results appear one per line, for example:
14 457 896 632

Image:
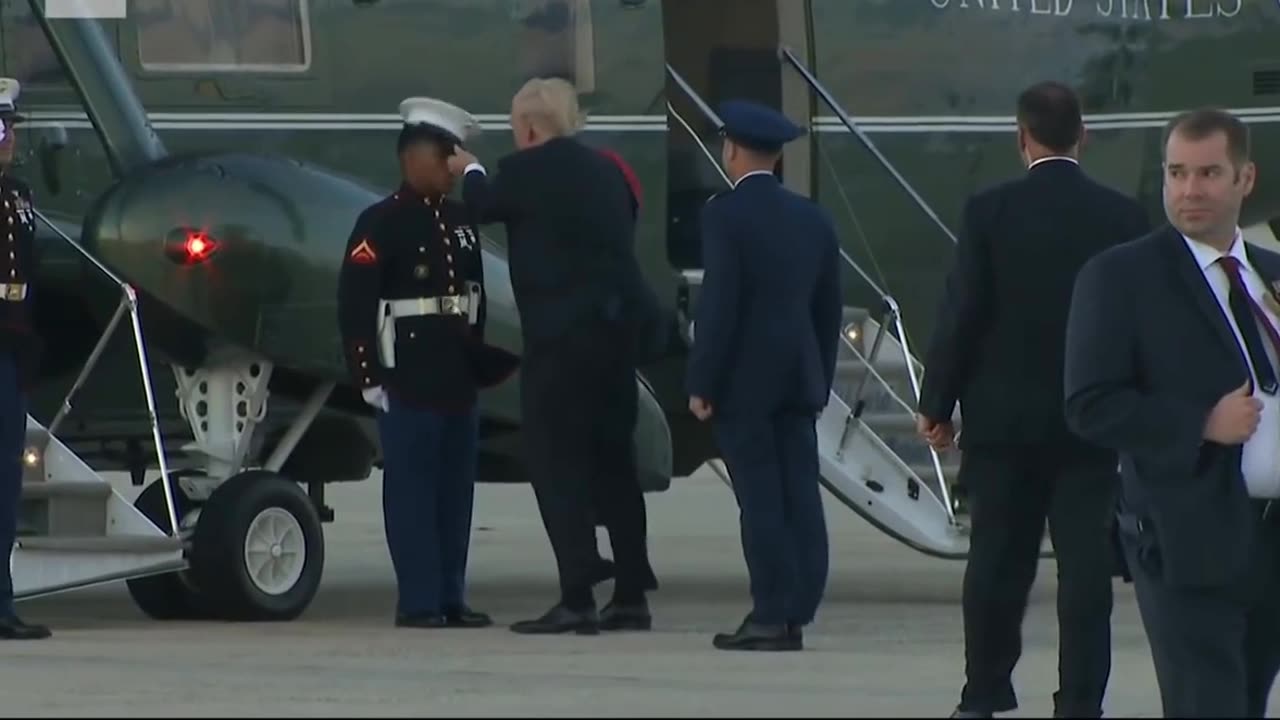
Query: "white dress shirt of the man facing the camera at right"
1183 228 1280 500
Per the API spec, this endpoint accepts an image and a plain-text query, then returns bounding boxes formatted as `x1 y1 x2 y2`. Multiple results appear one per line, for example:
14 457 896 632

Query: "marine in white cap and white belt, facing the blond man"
338 97 518 628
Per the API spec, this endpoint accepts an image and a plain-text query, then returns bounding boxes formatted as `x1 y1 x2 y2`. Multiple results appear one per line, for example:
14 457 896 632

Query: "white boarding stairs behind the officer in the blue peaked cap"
712 302 969 559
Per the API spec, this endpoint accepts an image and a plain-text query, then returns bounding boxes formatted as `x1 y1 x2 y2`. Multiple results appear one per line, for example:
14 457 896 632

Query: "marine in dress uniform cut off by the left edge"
0 78 50 639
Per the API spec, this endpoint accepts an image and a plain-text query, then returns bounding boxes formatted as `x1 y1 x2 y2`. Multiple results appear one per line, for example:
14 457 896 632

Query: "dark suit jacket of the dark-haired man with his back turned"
919 159 1149 458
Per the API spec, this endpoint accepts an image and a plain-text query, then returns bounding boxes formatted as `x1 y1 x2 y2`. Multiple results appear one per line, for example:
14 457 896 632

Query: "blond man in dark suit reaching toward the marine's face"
451 78 658 634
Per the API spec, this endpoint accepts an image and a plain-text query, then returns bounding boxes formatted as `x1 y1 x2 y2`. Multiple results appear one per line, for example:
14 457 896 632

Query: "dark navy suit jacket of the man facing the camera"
1066 227 1280 587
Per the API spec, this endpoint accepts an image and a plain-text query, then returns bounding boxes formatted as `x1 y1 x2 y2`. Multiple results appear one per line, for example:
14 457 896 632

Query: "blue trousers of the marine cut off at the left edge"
0 351 27 619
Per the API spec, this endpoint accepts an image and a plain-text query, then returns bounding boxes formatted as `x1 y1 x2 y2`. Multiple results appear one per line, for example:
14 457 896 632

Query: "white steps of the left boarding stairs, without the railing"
10 415 187 598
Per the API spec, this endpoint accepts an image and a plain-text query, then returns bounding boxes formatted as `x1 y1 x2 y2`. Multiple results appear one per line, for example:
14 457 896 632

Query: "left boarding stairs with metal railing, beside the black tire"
12 211 187 600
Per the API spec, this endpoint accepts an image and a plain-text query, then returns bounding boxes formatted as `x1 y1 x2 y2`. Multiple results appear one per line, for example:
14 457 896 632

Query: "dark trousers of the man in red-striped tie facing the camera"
1121 501 1280 717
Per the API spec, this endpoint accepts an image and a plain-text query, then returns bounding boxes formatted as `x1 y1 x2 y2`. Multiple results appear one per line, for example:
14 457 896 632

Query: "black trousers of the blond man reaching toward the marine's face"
520 323 657 610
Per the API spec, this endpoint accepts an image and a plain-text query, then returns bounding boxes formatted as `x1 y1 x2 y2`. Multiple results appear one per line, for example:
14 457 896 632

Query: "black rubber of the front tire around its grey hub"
191 470 324 621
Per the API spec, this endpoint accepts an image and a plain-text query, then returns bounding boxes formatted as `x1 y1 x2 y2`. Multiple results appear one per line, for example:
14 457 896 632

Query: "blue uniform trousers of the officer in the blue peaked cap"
712 409 829 625
